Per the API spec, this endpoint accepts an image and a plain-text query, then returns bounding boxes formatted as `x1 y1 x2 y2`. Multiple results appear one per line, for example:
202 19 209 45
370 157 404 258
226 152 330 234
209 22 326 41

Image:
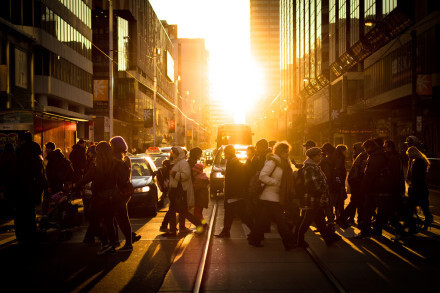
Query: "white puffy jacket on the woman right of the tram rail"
260 154 283 202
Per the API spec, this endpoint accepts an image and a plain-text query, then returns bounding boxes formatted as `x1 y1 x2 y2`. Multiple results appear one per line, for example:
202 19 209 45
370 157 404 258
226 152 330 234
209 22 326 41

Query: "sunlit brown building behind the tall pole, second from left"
92 0 176 151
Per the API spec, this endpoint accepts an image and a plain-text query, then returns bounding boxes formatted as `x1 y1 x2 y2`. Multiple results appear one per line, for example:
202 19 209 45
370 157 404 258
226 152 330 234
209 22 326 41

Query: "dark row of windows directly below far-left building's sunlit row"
34 51 92 93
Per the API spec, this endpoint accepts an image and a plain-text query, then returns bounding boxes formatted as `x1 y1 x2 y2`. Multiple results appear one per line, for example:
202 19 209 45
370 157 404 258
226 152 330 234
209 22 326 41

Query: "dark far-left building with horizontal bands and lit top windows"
0 0 93 154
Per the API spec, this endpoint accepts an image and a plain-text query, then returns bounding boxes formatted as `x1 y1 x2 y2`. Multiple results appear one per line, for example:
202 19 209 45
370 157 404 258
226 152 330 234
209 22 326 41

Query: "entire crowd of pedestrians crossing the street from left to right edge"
0 132 433 254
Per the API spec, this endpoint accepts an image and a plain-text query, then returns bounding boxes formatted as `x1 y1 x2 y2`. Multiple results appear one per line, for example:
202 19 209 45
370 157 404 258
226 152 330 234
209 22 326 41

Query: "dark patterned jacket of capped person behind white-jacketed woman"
303 158 329 208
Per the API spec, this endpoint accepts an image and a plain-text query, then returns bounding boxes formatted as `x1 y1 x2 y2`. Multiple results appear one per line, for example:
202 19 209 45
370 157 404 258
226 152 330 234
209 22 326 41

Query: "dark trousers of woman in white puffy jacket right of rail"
249 200 293 248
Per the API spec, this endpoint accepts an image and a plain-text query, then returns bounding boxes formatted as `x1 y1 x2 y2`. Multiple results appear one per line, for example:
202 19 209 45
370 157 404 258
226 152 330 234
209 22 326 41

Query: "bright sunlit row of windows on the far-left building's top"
36 5 92 60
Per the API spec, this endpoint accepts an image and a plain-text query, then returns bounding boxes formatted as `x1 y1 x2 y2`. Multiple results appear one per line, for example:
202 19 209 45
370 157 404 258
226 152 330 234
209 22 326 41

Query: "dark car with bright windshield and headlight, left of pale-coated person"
128 155 163 216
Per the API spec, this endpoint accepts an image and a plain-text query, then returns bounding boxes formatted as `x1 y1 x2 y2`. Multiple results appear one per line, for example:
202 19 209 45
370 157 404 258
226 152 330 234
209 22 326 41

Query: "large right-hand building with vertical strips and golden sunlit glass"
281 0 440 157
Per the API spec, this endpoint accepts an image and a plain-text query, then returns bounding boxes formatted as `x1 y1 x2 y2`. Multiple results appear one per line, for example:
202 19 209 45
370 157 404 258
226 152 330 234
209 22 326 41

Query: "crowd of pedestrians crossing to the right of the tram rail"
216 136 433 250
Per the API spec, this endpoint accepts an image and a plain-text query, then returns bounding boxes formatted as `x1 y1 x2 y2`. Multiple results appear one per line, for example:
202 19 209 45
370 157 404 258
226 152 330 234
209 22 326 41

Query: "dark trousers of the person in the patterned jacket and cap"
294 207 333 245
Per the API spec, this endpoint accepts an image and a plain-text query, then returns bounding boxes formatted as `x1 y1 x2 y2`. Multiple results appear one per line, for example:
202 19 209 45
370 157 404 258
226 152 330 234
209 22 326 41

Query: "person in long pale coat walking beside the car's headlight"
164 147 203 236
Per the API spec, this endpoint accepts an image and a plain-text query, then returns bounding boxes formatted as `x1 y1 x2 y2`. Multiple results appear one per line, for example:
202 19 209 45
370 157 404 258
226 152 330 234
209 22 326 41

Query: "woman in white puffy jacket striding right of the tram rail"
248 142 294 250
